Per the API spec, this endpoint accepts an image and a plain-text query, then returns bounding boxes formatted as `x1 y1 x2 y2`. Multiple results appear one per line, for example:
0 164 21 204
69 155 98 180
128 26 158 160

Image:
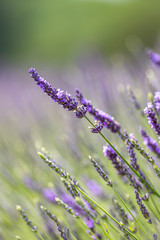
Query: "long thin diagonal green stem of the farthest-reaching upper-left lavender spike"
84 116 160 197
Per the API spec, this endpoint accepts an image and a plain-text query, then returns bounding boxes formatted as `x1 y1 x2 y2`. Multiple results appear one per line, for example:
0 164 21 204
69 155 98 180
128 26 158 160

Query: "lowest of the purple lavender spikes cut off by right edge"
140 128 160 158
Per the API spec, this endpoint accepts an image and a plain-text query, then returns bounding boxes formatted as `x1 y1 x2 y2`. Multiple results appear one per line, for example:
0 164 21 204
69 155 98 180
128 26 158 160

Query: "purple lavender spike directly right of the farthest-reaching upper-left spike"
75 89 121 133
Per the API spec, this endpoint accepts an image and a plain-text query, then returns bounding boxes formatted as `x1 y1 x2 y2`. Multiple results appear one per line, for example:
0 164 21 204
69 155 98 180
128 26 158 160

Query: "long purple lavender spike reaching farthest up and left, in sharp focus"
29 68 87 118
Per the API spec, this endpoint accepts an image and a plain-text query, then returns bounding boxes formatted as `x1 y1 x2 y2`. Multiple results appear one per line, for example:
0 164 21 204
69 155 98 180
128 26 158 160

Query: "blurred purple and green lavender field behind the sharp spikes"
0 53 160 240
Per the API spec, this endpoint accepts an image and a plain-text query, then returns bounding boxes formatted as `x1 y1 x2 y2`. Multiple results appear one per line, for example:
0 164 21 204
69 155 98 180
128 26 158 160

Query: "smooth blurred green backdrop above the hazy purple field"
0 0 160 63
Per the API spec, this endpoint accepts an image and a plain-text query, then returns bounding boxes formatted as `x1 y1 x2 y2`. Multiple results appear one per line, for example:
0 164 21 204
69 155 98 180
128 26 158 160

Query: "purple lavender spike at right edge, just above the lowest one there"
144 102 160 136
